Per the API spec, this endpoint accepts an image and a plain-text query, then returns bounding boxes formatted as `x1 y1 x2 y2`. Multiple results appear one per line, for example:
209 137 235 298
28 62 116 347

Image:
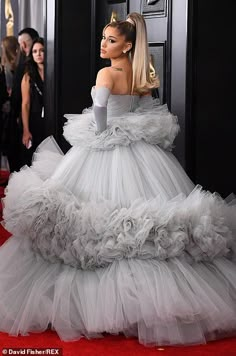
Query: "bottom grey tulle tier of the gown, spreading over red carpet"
0 236 236 345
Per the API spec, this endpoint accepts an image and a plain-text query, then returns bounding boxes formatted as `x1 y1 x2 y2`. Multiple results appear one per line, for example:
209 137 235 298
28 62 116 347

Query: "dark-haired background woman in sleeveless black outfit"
21 37 45 166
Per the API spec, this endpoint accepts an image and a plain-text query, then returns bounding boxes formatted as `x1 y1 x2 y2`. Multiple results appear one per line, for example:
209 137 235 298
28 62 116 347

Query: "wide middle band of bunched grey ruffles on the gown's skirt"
4 168 236 270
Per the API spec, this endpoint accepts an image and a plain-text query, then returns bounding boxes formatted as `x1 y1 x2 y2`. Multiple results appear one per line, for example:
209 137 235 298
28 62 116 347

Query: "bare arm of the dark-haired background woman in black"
21 74 32 148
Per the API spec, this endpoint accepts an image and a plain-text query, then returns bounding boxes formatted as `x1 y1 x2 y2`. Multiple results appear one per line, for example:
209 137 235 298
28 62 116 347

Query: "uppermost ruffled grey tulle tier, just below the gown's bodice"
63 97 179 151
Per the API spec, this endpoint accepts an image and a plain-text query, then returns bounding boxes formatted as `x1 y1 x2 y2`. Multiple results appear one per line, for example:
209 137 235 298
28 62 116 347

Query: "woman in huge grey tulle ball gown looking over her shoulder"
0 13 236 345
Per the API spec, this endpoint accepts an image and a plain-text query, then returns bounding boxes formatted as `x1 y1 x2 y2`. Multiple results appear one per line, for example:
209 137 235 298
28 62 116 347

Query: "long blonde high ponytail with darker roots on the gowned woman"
104 12 160 94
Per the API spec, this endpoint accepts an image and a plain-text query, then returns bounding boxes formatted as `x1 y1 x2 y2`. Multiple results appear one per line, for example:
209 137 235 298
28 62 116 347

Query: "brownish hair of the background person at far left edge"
2 36 20 71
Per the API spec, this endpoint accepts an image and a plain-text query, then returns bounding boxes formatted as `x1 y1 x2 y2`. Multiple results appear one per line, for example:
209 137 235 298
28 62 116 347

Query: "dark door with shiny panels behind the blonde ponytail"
129 0 188 168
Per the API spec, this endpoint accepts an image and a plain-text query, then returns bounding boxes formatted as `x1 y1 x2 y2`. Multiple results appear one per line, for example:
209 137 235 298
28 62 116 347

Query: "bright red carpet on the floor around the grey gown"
0 170 236 356
